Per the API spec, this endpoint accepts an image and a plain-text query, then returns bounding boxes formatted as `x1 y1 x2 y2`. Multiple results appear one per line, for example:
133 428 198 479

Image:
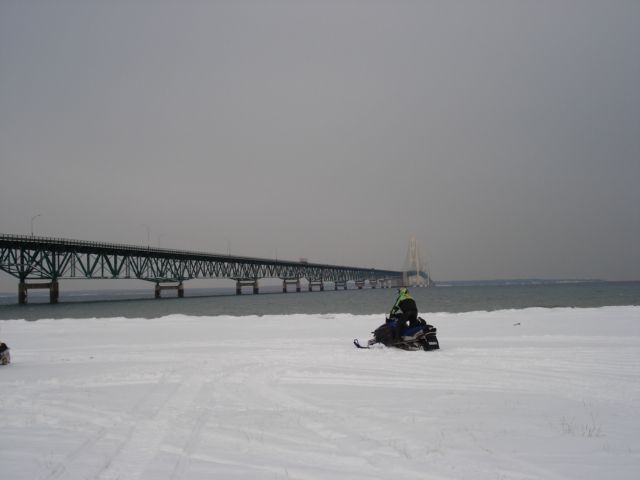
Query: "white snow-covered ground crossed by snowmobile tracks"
0 307 640 480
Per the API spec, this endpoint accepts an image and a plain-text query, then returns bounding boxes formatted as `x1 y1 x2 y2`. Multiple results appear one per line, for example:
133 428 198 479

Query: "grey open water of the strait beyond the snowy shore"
0 282 640 320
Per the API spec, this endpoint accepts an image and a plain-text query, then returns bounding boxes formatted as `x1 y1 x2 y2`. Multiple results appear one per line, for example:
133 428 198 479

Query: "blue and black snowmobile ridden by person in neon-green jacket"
353 317 440 350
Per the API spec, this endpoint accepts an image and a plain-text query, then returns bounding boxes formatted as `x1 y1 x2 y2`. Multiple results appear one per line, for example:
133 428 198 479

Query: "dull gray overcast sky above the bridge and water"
0 0 640 289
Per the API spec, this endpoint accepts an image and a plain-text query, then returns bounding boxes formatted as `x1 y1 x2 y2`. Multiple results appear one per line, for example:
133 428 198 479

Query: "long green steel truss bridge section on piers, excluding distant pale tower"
0 234 403 304
